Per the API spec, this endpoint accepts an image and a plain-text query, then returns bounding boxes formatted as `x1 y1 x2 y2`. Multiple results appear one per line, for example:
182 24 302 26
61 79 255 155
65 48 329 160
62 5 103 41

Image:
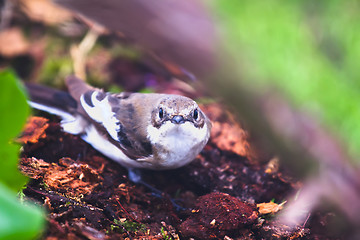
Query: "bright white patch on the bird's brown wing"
80 91 121 141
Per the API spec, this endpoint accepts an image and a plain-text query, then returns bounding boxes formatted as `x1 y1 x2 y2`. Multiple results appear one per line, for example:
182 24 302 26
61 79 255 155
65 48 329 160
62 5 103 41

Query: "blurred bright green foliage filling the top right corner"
212 0 360 161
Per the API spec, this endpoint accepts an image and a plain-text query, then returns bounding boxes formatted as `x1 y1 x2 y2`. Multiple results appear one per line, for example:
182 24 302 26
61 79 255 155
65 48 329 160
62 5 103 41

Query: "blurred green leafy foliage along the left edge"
0 71 44 239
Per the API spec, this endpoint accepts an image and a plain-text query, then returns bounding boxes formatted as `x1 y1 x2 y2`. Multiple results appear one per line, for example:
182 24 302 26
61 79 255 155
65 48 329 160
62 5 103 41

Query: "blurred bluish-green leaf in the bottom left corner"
0 183 44 240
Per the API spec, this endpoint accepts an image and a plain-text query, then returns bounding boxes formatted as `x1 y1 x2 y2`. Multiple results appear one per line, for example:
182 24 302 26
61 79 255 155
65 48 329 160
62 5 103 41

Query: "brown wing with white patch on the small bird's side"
66 77 152 159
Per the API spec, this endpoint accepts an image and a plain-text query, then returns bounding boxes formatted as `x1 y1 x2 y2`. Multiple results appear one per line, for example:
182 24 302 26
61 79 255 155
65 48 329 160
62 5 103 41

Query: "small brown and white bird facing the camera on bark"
27 76 211 182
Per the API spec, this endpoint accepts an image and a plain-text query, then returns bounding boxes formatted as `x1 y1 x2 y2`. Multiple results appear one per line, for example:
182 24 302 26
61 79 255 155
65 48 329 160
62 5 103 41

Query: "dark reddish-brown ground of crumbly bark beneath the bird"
16 103 344 239
